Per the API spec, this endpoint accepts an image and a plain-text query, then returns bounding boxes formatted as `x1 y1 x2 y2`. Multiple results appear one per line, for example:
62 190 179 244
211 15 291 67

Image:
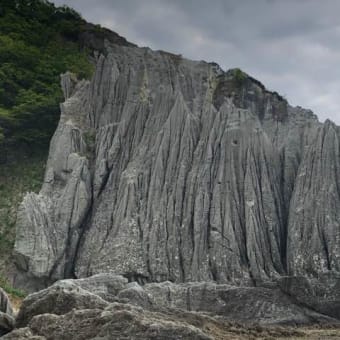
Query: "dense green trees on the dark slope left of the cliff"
0 0 93 148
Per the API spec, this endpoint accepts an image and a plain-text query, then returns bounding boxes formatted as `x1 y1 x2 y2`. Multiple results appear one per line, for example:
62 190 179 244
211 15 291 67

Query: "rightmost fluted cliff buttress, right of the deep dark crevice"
287 121 340 276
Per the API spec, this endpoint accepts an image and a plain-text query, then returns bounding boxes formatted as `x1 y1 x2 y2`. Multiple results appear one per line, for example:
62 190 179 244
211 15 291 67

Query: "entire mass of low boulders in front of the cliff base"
3 274 336 340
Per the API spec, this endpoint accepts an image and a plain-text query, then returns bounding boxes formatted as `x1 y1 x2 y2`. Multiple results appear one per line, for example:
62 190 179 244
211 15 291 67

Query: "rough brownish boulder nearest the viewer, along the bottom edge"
26 304 212 340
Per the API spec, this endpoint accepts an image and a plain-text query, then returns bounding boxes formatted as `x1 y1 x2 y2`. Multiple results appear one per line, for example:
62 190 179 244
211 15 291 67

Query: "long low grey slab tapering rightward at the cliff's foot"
138 282 336 325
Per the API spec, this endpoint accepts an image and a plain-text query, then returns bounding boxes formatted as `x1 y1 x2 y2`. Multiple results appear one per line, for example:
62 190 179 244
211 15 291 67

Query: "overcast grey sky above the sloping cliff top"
54 0 340 124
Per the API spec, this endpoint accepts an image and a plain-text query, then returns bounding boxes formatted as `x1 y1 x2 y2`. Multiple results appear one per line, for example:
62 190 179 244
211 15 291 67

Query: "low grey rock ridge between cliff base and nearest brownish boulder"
11 274 339 328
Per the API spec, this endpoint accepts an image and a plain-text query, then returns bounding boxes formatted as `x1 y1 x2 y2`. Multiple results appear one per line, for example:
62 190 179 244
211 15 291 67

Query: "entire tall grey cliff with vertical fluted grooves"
14 36 340 290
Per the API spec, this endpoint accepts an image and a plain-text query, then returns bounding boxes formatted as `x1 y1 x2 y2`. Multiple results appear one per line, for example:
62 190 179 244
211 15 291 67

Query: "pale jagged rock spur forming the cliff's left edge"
14 78 92 290
